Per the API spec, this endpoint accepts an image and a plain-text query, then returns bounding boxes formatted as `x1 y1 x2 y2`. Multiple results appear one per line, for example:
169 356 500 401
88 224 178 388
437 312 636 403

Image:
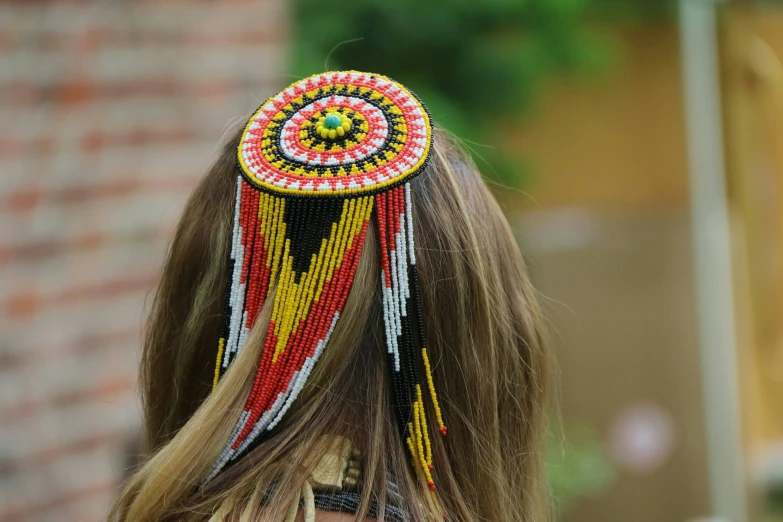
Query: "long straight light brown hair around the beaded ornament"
109 124 548 522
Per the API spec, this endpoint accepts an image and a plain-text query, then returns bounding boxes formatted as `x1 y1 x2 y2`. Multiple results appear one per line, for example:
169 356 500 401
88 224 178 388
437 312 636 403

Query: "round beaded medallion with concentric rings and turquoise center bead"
238 71 432 196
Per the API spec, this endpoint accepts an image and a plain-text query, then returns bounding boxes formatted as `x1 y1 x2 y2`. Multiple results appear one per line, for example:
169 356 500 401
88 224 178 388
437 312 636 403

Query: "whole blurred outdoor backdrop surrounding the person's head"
0 0 783 522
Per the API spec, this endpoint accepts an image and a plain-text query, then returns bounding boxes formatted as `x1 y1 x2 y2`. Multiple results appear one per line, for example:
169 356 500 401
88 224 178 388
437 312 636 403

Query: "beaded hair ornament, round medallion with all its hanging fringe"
207 71 446 489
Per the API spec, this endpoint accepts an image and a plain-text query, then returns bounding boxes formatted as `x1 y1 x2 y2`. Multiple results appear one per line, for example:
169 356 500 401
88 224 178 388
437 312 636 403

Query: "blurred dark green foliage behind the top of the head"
294 0 620 186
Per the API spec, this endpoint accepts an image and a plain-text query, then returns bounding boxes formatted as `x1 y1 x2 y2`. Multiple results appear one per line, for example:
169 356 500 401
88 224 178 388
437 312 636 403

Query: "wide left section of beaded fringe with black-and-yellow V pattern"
206 178 373 481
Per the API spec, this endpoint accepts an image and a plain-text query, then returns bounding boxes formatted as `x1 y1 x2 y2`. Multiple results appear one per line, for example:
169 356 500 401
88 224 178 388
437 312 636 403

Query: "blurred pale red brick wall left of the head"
0 0 286 522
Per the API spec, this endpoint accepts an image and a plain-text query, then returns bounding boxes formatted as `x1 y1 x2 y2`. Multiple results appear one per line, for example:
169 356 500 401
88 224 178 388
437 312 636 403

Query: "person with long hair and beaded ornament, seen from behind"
110 72 547 522
